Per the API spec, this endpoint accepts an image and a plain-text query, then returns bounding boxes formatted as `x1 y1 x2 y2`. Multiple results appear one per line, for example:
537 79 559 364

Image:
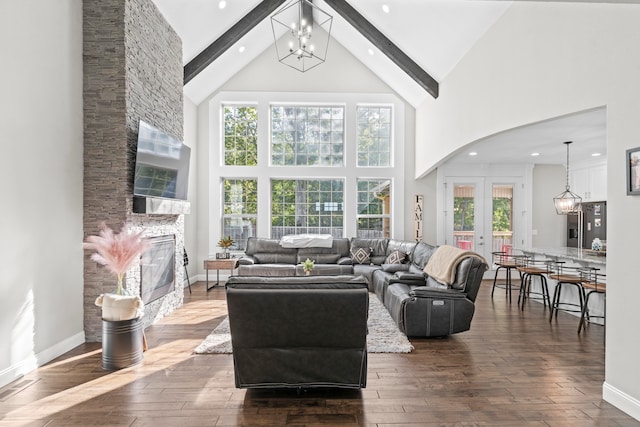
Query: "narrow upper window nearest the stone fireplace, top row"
223 105 258 166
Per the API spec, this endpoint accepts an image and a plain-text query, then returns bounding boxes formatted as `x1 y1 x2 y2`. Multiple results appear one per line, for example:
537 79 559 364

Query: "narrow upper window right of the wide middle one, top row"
357 107 391 167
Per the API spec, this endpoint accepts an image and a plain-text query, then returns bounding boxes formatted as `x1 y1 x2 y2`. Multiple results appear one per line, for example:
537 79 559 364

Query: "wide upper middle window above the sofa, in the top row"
271 105 344 166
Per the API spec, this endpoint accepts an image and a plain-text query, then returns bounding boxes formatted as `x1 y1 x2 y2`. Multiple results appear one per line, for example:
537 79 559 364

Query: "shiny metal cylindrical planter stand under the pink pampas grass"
102 317 144 371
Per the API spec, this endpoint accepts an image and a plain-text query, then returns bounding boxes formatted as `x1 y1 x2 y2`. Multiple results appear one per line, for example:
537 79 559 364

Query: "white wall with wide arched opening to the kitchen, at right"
416 2 640 419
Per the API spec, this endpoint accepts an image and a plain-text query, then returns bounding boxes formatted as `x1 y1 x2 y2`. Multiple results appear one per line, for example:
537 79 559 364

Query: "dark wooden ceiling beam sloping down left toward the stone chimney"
184 0 286 84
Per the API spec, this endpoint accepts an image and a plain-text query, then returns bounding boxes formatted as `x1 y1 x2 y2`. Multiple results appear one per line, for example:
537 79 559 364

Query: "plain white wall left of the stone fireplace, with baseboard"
0 0 85 386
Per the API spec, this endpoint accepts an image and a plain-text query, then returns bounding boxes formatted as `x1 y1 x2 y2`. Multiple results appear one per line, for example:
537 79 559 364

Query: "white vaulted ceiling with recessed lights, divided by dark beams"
154 0 511 106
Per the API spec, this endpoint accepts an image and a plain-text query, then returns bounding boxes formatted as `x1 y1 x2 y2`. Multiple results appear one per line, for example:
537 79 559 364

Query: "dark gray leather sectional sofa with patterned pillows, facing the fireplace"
238 238 488 337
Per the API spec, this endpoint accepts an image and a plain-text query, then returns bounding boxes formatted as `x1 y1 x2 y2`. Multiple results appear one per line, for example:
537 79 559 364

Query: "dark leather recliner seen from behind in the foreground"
226 276 369 389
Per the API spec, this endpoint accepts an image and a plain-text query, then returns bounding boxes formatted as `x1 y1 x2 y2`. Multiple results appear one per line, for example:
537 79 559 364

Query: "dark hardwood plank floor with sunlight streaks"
0 282 640 427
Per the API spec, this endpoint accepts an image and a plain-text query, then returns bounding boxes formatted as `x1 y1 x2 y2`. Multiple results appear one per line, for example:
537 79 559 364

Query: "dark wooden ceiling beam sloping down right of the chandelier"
324 0 439 98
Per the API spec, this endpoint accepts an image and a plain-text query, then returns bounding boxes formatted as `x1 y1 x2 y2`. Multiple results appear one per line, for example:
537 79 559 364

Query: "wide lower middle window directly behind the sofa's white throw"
271 179 344 239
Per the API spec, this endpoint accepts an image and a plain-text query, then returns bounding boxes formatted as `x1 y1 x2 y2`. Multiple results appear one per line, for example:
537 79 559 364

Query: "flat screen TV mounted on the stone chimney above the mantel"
133 120 191 200
